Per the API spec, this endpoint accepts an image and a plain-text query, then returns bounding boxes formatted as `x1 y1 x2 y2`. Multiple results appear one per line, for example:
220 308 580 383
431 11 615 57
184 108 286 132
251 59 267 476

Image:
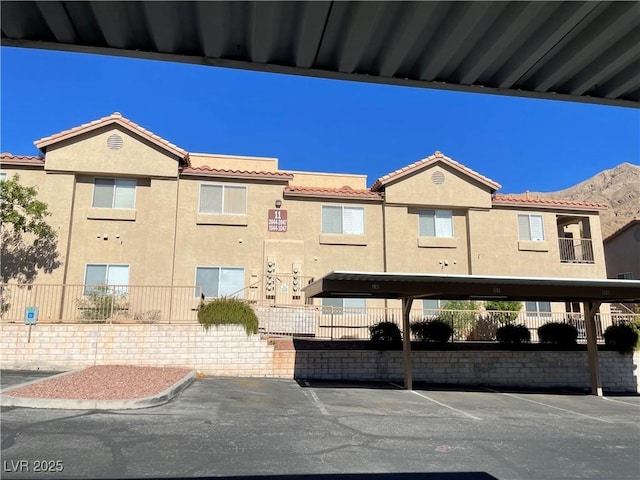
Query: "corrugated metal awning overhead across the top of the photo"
1 0 640 107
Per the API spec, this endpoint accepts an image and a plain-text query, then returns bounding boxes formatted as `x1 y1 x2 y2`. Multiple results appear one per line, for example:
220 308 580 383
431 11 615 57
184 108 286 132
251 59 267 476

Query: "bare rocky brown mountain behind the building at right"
534 163 640 239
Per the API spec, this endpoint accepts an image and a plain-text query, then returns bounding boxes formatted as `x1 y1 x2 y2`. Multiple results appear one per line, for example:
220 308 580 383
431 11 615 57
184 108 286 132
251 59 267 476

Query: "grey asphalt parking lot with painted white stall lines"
1 372 640 480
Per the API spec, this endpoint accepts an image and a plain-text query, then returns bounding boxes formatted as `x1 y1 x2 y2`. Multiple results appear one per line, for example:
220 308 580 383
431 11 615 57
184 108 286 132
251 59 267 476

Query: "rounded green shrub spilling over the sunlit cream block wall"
198 297 258 335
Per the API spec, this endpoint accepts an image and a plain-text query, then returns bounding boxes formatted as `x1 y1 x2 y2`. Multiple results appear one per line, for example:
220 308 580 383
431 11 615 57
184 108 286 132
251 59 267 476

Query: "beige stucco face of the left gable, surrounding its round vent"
45 125 178 178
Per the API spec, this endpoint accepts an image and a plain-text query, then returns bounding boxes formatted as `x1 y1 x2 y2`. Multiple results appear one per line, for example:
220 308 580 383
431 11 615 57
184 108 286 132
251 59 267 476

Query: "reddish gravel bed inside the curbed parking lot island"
3 365 191 400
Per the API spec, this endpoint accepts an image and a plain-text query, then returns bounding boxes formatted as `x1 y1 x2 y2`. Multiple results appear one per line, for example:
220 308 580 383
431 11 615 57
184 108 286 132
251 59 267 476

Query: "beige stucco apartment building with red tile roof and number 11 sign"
1 113 607 330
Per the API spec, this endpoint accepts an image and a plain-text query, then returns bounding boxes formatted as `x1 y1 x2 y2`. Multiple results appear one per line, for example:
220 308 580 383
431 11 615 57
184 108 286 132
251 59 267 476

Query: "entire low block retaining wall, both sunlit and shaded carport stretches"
0 324 640 393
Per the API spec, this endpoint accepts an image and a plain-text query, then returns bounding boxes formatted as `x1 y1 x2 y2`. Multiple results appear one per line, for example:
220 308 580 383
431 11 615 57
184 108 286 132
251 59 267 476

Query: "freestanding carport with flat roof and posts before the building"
303 271 640 396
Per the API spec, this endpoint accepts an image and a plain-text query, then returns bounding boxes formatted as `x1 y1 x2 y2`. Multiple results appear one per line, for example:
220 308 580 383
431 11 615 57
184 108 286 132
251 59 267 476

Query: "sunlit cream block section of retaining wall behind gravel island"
0 324 278 376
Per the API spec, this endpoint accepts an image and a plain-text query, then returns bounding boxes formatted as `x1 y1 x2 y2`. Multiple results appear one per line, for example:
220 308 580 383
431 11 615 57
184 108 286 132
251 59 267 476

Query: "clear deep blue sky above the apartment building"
0 47 640 193
